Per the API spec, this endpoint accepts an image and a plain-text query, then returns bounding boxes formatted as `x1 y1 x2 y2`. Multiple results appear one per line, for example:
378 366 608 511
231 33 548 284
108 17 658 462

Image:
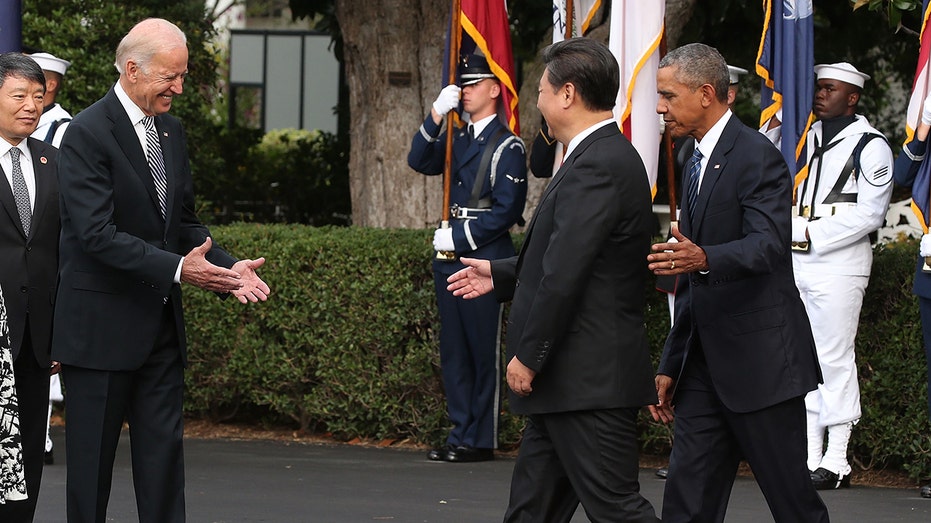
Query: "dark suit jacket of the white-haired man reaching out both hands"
52 89 235 370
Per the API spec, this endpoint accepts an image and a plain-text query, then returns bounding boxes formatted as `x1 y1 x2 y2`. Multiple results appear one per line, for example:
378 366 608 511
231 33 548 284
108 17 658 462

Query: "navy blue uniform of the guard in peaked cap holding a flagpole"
407 116 527 449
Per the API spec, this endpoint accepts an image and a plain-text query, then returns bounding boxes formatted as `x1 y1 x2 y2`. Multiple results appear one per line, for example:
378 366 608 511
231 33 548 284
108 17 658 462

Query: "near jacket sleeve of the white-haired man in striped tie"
58 121 181 289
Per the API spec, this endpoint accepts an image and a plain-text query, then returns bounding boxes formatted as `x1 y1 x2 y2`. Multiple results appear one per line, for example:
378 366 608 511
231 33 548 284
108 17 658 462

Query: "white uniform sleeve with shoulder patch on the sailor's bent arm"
808 139 892 253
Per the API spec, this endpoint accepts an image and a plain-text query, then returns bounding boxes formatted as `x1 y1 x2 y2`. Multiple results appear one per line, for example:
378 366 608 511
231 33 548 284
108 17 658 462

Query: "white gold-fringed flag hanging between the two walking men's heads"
608 0 666 200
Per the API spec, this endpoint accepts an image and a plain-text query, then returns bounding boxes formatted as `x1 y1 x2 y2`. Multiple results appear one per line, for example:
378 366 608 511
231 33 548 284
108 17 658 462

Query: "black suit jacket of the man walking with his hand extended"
492 124 656 414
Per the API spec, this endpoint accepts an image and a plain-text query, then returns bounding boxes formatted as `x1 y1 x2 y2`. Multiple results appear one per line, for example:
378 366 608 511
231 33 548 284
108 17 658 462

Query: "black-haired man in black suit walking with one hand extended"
448 38 658 522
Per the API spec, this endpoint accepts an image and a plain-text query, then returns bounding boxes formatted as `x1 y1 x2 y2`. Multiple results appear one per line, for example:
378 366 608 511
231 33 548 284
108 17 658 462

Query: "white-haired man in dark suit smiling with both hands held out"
52 19 269 522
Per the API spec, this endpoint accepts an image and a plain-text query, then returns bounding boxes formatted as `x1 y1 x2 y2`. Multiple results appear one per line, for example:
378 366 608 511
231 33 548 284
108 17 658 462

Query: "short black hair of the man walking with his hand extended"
542 38 621 111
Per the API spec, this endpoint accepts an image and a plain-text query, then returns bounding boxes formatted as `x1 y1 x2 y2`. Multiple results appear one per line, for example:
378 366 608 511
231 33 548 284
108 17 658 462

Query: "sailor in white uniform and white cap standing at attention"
792 62 893 489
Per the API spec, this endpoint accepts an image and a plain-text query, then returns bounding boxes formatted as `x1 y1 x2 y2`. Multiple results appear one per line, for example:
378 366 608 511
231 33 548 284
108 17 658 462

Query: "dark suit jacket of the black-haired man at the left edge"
0 138 60 367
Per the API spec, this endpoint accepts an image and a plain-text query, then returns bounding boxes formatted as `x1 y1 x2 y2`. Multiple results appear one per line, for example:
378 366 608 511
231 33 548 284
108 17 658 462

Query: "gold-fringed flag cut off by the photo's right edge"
905 0 931 234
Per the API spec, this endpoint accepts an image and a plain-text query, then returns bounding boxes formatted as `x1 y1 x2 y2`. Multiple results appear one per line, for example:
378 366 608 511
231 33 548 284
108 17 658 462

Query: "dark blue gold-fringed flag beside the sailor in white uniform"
756 0 815 186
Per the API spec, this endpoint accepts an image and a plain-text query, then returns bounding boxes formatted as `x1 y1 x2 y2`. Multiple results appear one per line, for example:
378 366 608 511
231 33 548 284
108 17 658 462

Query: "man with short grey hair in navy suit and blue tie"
648 44 828 523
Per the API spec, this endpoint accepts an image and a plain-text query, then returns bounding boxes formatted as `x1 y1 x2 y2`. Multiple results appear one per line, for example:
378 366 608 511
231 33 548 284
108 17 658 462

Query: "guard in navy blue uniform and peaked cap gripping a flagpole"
407 55 527 462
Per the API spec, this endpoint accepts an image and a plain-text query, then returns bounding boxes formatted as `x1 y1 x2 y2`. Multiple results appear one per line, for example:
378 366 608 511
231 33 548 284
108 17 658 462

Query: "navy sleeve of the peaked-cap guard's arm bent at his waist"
450 136 527 254
